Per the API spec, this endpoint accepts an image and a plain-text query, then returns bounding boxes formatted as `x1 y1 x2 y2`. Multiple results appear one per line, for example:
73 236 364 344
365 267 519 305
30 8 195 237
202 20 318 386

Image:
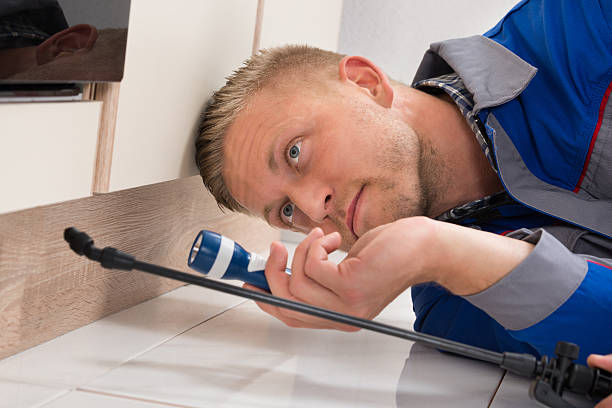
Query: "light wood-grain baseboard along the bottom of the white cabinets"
0 176 280 358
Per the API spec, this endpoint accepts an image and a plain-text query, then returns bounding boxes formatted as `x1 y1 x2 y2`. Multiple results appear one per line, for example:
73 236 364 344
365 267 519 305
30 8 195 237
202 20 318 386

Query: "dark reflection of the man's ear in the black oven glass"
36 24 98 65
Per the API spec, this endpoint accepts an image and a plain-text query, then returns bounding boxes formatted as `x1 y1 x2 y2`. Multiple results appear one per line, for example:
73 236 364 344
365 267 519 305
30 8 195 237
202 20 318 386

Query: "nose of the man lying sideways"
289 180 334 223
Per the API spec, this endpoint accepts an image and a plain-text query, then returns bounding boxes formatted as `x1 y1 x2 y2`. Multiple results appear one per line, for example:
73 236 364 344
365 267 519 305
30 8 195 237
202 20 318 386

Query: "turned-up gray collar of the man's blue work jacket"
412 35 538 113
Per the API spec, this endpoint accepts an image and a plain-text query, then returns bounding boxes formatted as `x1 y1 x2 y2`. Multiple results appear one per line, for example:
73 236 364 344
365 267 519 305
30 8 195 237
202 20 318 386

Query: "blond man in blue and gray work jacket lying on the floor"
196 0 612 362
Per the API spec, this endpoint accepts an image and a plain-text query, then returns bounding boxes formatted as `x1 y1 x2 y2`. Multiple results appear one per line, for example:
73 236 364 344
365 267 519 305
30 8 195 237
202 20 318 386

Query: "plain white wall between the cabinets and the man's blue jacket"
338 0 518 83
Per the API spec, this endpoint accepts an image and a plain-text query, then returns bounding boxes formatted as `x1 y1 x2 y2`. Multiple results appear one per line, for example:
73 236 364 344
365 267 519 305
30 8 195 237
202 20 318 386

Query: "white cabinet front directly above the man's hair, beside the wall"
260 0 342 51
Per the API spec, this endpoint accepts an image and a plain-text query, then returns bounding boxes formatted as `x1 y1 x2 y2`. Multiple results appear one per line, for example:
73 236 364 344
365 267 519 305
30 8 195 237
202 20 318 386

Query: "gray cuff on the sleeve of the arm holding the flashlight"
464 226 612 330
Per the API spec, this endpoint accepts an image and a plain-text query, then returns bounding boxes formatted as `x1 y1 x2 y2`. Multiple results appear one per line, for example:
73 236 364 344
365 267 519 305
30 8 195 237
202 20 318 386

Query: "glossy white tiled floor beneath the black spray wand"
0 241 588 408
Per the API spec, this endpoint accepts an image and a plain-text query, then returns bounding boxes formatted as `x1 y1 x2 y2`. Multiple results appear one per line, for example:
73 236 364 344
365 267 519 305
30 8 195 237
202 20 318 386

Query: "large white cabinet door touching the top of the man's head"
110 0 257 191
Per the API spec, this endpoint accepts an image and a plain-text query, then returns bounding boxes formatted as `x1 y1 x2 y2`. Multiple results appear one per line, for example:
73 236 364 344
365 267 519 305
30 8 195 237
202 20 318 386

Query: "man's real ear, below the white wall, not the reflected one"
338 56 393 108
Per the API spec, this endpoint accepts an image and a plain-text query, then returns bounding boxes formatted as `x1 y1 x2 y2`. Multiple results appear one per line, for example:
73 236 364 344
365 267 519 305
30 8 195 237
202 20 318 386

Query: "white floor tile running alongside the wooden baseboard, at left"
0 286 243 390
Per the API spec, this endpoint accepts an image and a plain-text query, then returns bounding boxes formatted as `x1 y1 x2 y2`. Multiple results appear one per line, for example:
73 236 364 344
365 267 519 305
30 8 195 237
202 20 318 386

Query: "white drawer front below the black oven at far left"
0 102 102 213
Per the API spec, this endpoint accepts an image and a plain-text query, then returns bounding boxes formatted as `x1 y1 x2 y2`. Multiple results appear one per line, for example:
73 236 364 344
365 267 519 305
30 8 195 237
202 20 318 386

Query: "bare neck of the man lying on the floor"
396 87 503 217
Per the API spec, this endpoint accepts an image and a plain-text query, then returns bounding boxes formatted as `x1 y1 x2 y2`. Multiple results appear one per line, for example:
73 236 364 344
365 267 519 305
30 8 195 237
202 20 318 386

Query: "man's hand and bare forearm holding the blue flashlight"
245 217 532 331
